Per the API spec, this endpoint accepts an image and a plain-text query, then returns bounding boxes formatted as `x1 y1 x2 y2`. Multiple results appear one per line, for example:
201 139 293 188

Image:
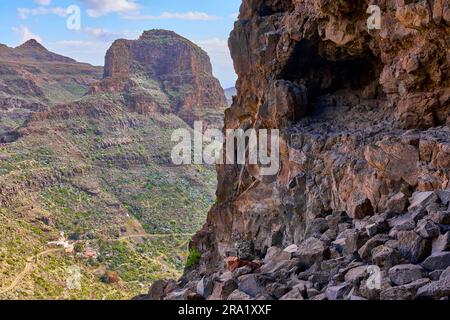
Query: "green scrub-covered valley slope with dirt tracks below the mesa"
0 34 225 299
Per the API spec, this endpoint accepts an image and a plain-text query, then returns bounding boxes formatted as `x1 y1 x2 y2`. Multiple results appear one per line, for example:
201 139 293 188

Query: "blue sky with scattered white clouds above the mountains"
0 0 241 88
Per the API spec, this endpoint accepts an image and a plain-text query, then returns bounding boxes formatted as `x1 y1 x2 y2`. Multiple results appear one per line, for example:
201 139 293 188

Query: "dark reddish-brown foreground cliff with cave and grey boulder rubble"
150 0 450 300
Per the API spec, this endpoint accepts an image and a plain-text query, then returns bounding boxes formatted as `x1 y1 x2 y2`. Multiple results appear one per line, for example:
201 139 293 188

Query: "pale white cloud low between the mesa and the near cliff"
194 38 237 88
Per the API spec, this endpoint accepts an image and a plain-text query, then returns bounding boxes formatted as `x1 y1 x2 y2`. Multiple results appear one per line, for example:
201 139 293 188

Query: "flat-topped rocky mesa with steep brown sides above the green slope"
91 30 227 123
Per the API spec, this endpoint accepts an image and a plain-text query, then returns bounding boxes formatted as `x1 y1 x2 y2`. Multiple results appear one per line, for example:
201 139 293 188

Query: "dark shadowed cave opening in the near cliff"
280 40 384 114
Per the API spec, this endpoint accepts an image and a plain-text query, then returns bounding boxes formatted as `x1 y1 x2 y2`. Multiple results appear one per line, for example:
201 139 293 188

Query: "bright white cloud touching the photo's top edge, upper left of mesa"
81 0 139 17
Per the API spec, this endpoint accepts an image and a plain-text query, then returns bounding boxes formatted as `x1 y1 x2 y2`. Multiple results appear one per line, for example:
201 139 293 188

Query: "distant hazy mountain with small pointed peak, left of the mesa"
0 40 103 143
